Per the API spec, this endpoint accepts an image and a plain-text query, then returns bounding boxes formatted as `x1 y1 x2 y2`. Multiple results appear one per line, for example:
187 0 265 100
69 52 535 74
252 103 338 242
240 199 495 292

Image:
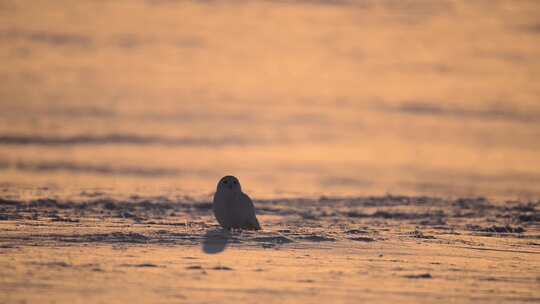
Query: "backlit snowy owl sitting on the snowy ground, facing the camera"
212 175 261 230
